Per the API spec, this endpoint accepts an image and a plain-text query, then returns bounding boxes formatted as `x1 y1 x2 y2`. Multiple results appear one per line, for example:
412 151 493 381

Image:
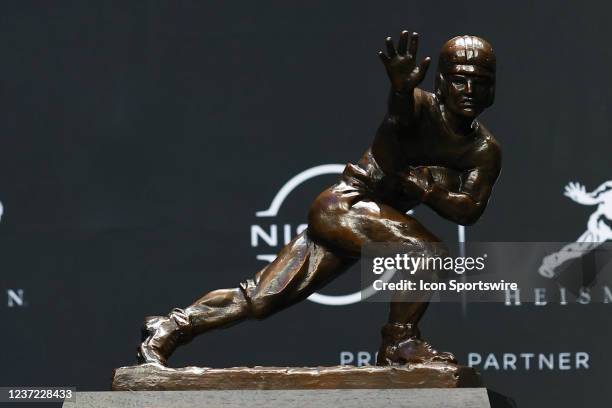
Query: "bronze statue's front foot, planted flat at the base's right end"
376 324 457 365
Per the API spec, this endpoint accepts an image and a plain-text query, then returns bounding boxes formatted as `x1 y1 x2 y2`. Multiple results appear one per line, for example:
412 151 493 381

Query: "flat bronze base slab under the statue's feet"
112 363 482 391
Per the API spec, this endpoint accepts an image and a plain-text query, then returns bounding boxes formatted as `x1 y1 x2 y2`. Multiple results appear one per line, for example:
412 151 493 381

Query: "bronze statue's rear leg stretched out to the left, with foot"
138 232 355 365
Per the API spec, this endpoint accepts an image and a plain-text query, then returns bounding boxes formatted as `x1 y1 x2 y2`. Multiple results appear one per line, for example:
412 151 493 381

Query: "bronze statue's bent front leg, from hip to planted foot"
309 183 454 365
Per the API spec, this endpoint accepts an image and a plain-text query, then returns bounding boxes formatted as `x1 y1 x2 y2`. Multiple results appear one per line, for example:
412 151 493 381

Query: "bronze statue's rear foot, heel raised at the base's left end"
137 309 191 366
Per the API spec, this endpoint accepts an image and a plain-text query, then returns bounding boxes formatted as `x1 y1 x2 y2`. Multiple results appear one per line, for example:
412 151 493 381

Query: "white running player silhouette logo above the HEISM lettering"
539 180 612 278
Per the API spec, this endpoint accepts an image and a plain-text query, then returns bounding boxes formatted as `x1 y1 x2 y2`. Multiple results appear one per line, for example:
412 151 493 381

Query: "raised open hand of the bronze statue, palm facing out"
378 30 431 91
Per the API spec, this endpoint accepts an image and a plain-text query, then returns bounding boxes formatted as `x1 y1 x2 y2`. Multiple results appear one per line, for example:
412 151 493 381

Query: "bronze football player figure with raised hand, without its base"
138 31 501 376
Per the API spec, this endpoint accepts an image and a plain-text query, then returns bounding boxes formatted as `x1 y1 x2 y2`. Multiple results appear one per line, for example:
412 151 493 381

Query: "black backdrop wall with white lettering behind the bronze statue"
0 1 612 407
